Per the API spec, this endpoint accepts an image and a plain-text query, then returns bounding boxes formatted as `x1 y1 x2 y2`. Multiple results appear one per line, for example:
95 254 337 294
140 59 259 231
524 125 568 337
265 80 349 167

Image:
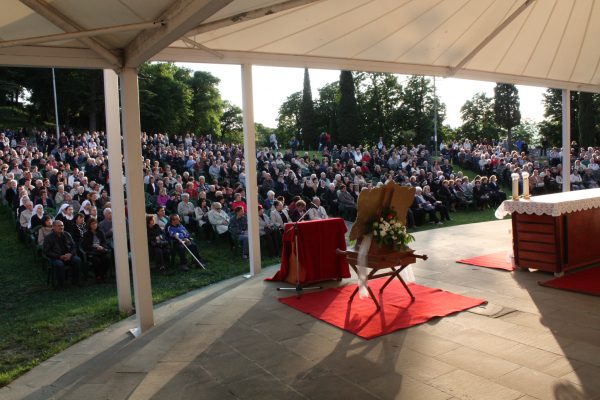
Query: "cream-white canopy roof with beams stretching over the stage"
0 0 600 92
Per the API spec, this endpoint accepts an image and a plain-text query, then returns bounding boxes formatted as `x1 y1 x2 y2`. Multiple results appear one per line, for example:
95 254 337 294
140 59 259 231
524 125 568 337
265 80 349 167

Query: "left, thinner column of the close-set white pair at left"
104 69 133 314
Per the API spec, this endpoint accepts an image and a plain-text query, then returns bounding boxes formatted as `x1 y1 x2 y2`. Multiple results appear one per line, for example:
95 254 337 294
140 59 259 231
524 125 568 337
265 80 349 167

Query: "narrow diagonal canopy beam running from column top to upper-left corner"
20 0 122 68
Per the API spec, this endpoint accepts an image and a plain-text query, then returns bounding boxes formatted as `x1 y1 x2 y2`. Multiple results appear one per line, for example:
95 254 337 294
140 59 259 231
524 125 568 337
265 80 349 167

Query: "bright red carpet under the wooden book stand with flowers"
279 278 485 339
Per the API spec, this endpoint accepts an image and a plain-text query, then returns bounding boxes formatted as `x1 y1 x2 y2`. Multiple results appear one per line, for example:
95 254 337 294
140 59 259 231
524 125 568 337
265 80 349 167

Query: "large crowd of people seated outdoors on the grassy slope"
0 131 600 284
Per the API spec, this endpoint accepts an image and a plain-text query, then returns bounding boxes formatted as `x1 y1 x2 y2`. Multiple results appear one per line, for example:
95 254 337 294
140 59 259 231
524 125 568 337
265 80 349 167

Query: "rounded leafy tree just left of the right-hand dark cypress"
460 93 500 141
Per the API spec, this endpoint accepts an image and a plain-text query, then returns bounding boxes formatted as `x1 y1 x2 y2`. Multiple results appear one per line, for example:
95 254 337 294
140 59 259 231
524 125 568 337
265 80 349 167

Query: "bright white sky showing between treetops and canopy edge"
178 63 546 128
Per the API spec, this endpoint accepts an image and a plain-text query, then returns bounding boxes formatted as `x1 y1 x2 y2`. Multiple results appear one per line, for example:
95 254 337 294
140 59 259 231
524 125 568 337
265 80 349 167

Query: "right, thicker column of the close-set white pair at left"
120 68 154 336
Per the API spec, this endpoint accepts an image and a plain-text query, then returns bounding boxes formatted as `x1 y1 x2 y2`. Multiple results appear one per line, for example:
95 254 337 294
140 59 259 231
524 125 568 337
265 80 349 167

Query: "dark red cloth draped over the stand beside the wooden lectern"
267 218 350 284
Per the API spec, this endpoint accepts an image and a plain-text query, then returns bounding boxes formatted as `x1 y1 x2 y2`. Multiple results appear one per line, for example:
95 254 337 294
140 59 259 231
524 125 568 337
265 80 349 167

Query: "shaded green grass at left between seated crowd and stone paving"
0 207 278 387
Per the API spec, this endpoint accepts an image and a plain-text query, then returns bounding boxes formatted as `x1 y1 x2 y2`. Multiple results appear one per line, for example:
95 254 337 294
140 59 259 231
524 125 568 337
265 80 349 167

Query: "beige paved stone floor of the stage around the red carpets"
0 221 600 400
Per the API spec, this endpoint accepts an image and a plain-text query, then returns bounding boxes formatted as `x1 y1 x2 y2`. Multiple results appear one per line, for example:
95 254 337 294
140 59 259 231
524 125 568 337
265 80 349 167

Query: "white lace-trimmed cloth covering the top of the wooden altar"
495 189 600 219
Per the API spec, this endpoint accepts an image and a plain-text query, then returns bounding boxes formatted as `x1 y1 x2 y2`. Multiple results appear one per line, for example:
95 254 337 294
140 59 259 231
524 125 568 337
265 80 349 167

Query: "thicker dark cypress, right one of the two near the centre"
337 71 364 144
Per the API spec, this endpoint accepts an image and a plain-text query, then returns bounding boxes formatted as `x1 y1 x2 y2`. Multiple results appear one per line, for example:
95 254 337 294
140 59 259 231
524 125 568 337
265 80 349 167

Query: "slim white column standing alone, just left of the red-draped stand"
242 64 261 275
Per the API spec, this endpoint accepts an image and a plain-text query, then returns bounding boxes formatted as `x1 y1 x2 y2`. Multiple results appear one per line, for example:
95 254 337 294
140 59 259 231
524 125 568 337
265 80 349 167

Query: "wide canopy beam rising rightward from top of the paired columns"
124 0 233 68
